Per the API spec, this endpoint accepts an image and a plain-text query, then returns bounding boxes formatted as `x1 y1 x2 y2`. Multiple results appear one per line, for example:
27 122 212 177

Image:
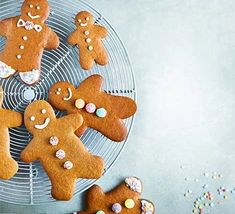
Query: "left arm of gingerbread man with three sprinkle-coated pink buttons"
20 139 41 163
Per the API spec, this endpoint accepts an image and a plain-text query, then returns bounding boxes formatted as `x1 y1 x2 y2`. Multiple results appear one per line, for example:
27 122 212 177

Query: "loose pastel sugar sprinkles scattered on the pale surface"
180 166 235 214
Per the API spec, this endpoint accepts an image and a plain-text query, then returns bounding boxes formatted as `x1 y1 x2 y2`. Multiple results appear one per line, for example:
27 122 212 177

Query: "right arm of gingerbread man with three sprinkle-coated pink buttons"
58 113 83 132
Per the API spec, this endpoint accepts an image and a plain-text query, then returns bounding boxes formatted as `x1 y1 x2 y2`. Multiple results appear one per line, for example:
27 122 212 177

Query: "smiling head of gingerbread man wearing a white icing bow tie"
21 0 50 23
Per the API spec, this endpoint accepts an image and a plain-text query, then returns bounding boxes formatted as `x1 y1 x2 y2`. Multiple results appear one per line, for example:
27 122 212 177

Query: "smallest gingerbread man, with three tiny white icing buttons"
68 11 108 70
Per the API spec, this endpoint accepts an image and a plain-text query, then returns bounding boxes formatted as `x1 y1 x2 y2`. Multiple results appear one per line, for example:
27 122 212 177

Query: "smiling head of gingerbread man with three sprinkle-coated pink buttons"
24 100 56 134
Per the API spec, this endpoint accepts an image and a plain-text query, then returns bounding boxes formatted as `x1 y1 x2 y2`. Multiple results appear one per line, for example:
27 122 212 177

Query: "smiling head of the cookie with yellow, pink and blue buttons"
49 82 76 111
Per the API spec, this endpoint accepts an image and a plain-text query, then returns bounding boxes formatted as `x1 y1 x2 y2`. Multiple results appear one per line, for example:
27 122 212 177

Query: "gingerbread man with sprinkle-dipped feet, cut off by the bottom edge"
78 177 155 214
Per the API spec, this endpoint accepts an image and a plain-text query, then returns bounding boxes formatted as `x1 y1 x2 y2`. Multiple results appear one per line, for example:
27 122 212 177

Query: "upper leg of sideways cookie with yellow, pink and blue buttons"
109 95 137 119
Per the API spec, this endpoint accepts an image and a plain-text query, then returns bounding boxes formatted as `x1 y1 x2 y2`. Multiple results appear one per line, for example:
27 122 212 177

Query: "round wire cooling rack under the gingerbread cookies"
0 0 136 205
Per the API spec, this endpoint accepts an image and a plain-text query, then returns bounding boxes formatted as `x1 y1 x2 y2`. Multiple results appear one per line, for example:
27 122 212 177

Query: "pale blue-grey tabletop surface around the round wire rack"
0 0 235 214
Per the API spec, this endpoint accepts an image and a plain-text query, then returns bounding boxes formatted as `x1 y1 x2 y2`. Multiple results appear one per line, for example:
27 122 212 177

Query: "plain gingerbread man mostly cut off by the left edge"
0 87 23 180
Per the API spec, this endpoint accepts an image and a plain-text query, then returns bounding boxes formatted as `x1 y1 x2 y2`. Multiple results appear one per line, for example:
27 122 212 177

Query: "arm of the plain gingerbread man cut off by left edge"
4 109 23 128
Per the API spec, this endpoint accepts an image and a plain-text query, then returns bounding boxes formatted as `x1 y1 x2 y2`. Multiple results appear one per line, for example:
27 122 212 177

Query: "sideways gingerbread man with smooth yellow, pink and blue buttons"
49 75 137 142
